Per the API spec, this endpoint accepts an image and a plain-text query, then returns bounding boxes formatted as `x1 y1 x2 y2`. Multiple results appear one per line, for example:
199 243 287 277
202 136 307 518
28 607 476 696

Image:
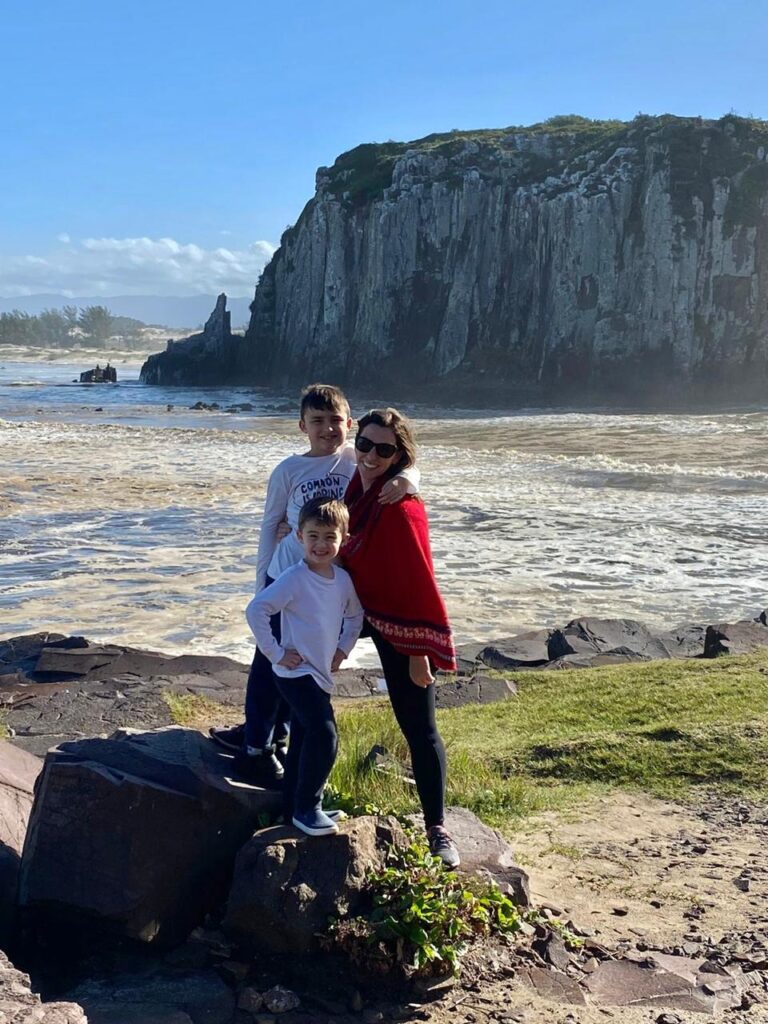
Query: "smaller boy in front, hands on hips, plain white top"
246 497 362 836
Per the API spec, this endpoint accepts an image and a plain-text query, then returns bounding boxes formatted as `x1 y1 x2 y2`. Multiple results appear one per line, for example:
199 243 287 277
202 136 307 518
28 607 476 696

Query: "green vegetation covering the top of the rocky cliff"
328 114 768 212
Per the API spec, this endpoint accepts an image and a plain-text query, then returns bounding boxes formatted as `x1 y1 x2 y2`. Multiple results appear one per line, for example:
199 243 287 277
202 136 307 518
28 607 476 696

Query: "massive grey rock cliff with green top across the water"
138 116 768 393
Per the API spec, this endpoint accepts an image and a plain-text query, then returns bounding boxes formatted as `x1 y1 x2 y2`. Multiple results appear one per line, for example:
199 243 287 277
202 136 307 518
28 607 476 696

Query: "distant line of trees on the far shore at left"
0 306 145 348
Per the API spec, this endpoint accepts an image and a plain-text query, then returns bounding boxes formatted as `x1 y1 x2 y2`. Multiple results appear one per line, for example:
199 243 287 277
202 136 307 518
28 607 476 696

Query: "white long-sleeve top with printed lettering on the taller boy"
256 444 421 592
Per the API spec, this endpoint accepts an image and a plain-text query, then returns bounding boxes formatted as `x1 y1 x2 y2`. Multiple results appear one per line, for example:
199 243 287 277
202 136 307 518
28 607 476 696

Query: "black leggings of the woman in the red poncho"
368 624 445 828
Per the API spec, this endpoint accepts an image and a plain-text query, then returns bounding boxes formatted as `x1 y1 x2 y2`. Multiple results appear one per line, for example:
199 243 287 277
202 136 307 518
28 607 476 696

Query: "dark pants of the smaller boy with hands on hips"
274 676 339 821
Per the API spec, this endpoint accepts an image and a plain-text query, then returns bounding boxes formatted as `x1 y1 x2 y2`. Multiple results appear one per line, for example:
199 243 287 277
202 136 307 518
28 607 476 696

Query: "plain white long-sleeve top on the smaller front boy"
246 560 362 693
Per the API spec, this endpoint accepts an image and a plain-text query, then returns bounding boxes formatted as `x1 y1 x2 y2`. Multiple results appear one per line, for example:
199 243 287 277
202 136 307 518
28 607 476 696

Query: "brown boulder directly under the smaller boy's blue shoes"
224 817 408 953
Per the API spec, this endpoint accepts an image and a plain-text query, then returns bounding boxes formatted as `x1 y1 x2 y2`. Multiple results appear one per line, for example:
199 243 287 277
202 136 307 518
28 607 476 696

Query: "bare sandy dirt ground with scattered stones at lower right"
413 794 768 1024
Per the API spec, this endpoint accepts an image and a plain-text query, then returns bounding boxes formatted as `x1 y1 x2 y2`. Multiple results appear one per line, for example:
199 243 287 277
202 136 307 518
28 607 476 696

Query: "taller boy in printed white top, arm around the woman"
210 384 419 788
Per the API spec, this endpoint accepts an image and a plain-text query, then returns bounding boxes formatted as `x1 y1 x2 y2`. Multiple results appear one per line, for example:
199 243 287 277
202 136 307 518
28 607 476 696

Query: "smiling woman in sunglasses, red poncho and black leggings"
341 409 460 867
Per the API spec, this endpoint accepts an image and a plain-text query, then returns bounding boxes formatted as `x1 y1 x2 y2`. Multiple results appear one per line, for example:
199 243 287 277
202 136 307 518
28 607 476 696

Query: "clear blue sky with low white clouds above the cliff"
0 0 768 296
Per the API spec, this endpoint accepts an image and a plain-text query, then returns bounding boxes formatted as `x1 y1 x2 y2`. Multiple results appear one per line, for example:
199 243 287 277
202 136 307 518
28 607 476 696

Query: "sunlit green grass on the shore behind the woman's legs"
332 651 768 829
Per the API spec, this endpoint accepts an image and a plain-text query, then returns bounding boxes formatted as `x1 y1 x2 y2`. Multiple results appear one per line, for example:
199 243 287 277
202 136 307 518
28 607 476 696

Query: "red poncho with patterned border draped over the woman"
341 473 456 672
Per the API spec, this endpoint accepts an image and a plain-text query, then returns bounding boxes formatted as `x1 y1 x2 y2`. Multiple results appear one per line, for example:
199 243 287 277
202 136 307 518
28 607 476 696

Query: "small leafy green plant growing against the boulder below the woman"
331 839 522 976
